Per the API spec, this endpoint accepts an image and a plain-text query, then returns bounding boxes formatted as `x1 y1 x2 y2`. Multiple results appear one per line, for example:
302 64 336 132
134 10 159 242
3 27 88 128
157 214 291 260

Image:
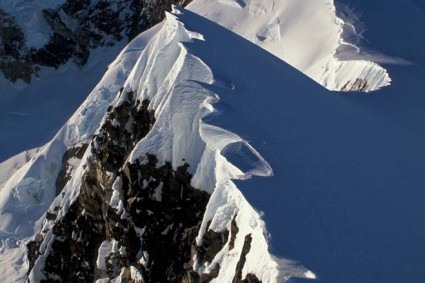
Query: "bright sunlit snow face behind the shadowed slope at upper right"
188 0 391 92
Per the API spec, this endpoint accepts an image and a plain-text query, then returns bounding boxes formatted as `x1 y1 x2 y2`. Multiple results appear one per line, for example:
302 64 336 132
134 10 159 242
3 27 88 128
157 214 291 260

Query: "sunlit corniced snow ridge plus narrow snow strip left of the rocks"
24 8 314 282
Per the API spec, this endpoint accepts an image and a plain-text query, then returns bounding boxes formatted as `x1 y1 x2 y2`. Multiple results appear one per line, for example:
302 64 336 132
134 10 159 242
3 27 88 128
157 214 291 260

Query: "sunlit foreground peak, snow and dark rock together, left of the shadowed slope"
2 5 318 282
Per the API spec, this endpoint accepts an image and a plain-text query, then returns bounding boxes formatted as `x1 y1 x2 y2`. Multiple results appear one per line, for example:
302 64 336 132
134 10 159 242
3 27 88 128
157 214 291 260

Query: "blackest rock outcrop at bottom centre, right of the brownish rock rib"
121 155 209 282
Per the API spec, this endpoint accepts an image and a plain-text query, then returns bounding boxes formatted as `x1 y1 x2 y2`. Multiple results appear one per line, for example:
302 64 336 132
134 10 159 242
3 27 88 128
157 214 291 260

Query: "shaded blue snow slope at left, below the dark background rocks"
0 44 119 162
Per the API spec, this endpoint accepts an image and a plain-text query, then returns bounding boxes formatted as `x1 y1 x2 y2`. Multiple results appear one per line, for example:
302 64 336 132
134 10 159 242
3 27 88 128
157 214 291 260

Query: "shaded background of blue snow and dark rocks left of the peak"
0 0 193 162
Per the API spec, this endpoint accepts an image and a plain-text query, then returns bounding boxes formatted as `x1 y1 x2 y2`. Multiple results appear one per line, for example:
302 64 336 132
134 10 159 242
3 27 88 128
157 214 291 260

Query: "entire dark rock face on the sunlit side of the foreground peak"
27 89 227 282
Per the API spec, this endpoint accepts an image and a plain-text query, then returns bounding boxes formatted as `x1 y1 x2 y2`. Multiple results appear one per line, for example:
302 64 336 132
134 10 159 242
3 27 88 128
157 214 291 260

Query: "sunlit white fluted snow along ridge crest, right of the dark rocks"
117 10 279 282
